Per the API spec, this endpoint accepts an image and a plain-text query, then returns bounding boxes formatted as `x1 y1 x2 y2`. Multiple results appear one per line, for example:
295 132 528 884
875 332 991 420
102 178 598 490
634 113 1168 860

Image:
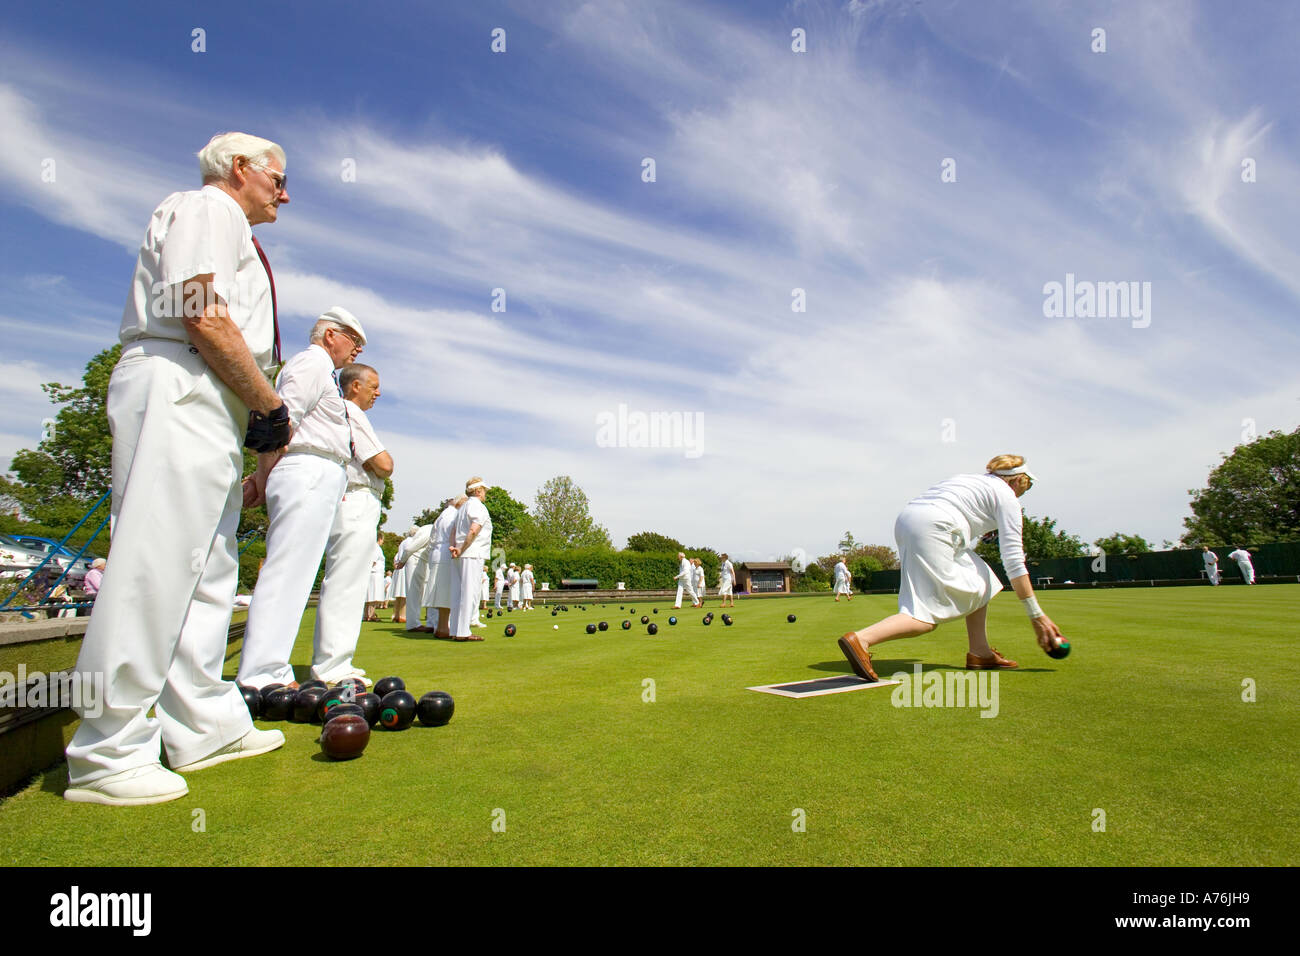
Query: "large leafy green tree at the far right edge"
1182 428 1300 548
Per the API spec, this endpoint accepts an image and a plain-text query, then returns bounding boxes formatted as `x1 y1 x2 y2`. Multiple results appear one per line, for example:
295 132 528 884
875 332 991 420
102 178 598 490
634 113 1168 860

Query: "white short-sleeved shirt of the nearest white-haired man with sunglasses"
118 186 276 371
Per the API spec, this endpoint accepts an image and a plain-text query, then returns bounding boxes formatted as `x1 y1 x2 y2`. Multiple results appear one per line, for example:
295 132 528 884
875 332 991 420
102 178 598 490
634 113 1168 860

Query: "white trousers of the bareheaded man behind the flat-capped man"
312 489 379 684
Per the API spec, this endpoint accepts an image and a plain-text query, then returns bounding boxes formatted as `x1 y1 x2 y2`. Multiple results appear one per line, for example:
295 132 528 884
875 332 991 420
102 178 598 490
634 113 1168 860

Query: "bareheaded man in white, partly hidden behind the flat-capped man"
312 362 399 684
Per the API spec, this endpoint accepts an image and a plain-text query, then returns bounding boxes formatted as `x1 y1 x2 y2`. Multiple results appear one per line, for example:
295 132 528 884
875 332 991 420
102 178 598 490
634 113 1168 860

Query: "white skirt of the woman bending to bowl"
894 505 1002 624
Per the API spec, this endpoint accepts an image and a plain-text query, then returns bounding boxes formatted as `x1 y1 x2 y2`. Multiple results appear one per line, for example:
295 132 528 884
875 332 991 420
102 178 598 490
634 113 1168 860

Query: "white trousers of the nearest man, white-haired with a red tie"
68 339 252 787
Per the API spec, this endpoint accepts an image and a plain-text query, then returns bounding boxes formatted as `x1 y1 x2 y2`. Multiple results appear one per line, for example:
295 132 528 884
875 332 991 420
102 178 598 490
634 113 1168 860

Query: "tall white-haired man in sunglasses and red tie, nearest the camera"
64 133 289 806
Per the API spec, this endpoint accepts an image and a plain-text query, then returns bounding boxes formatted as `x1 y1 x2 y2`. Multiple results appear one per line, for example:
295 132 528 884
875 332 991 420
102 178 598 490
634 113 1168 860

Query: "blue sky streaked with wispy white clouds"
0 0 1300 559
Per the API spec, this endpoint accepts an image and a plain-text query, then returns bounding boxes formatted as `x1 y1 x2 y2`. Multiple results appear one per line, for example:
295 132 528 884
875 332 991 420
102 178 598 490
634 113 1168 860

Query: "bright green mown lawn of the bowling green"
0 585 1300 866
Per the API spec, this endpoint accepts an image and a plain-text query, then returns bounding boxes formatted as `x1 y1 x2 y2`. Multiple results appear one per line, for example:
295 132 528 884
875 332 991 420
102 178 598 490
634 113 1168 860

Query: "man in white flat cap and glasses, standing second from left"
239 306 369 688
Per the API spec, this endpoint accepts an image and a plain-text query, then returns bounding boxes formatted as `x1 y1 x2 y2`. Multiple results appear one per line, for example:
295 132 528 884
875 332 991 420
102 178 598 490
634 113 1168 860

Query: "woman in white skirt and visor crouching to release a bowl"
840 455 1061 680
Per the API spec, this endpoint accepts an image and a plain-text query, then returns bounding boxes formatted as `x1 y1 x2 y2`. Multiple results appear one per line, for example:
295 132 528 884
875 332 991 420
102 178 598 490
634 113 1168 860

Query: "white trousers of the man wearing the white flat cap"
239 454 343 687
